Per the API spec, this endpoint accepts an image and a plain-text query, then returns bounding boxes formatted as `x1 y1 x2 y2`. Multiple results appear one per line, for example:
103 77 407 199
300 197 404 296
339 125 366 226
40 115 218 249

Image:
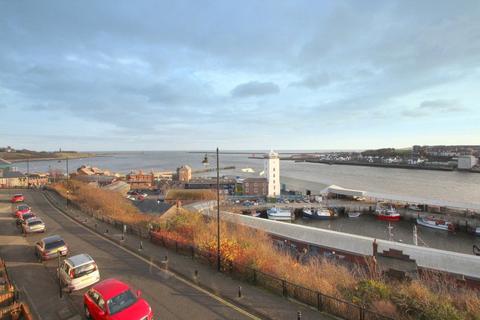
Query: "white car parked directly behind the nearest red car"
59 253 100 292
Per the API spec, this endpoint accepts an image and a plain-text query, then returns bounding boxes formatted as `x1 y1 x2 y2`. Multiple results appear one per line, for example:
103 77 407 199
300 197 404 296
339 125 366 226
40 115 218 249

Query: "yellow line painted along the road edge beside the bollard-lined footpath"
42 193 261 320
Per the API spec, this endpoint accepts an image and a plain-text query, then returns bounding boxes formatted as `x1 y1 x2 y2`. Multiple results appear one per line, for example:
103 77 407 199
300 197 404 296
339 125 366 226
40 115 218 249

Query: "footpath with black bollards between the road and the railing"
43 191 338 320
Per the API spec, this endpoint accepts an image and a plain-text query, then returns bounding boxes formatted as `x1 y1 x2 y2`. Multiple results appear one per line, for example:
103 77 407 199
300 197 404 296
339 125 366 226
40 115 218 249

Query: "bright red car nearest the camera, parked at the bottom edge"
83 279 153 320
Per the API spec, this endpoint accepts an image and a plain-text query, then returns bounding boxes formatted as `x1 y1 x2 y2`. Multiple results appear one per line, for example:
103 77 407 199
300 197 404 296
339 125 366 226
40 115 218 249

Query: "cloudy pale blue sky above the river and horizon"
0 0 480 151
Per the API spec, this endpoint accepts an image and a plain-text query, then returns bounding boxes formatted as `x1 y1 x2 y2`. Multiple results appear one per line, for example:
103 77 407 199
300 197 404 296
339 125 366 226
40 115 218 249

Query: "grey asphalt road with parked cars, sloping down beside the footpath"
0 191 255 320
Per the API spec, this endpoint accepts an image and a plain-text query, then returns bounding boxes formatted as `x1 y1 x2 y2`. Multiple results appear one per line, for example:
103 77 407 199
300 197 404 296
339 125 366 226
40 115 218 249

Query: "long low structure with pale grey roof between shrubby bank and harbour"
189 201 480 288
